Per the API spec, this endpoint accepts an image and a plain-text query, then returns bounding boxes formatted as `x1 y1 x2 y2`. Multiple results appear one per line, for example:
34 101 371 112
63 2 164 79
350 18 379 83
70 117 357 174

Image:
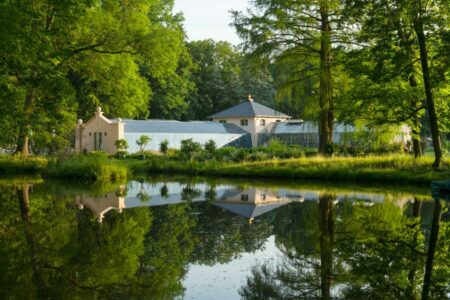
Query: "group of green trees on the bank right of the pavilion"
233 0 450 168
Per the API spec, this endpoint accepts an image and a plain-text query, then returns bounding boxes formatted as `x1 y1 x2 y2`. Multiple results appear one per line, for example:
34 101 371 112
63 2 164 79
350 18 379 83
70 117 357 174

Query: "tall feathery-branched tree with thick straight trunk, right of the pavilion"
233 0 345 153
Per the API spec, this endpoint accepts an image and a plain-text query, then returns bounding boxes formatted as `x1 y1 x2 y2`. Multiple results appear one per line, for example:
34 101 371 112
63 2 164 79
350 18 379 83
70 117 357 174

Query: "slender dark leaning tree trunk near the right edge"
414 0 442 169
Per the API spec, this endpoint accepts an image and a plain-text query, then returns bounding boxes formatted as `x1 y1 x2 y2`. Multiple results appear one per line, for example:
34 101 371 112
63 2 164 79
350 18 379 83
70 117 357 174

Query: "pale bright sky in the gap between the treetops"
174 0 248 45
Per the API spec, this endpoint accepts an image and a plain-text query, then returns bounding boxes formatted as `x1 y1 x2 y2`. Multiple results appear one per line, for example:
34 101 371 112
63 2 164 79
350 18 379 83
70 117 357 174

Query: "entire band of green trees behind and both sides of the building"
0 0 450 167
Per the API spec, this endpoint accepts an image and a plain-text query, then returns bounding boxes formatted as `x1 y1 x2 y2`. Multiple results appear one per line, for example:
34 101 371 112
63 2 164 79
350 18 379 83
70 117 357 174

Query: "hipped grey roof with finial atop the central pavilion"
208 101 290 118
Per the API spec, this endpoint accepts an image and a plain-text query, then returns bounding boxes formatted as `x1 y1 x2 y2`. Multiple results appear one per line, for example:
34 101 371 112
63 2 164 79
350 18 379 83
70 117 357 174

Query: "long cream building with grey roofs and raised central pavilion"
75 96 411 154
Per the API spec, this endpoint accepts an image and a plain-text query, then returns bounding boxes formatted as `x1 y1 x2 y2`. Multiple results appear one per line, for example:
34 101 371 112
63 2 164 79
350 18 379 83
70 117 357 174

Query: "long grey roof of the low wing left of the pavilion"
122 119 247 134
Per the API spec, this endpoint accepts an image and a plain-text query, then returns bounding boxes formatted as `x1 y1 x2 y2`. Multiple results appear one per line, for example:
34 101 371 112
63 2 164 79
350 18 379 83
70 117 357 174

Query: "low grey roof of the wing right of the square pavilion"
270 120 355 134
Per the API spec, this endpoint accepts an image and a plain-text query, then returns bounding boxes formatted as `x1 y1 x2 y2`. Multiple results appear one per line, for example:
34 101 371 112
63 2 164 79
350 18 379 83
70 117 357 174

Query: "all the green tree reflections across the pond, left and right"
0 181 450 299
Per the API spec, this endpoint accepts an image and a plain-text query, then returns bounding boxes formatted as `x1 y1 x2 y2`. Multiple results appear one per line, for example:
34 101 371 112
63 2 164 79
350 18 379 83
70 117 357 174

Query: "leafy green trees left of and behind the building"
0 0 275 155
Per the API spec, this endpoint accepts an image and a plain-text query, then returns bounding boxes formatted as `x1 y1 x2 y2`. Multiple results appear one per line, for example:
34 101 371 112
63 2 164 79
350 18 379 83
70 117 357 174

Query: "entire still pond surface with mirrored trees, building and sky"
0 177 450 299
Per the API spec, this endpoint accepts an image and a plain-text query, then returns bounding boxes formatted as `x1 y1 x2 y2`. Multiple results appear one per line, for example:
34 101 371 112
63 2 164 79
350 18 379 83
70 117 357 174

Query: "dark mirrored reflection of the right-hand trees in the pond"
240 194 450 299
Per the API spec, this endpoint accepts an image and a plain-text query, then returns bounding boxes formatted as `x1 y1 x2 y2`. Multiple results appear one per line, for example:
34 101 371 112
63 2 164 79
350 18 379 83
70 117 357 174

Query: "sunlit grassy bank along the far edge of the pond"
0 154 450 185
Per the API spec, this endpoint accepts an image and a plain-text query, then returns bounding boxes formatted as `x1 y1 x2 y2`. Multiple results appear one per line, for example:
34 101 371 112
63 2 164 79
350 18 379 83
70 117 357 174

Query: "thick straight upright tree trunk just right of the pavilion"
319 1 334 154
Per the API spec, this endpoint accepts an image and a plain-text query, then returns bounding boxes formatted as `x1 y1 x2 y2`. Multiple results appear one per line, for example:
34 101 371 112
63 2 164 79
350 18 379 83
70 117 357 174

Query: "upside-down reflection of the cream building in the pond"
76 181 418 222
